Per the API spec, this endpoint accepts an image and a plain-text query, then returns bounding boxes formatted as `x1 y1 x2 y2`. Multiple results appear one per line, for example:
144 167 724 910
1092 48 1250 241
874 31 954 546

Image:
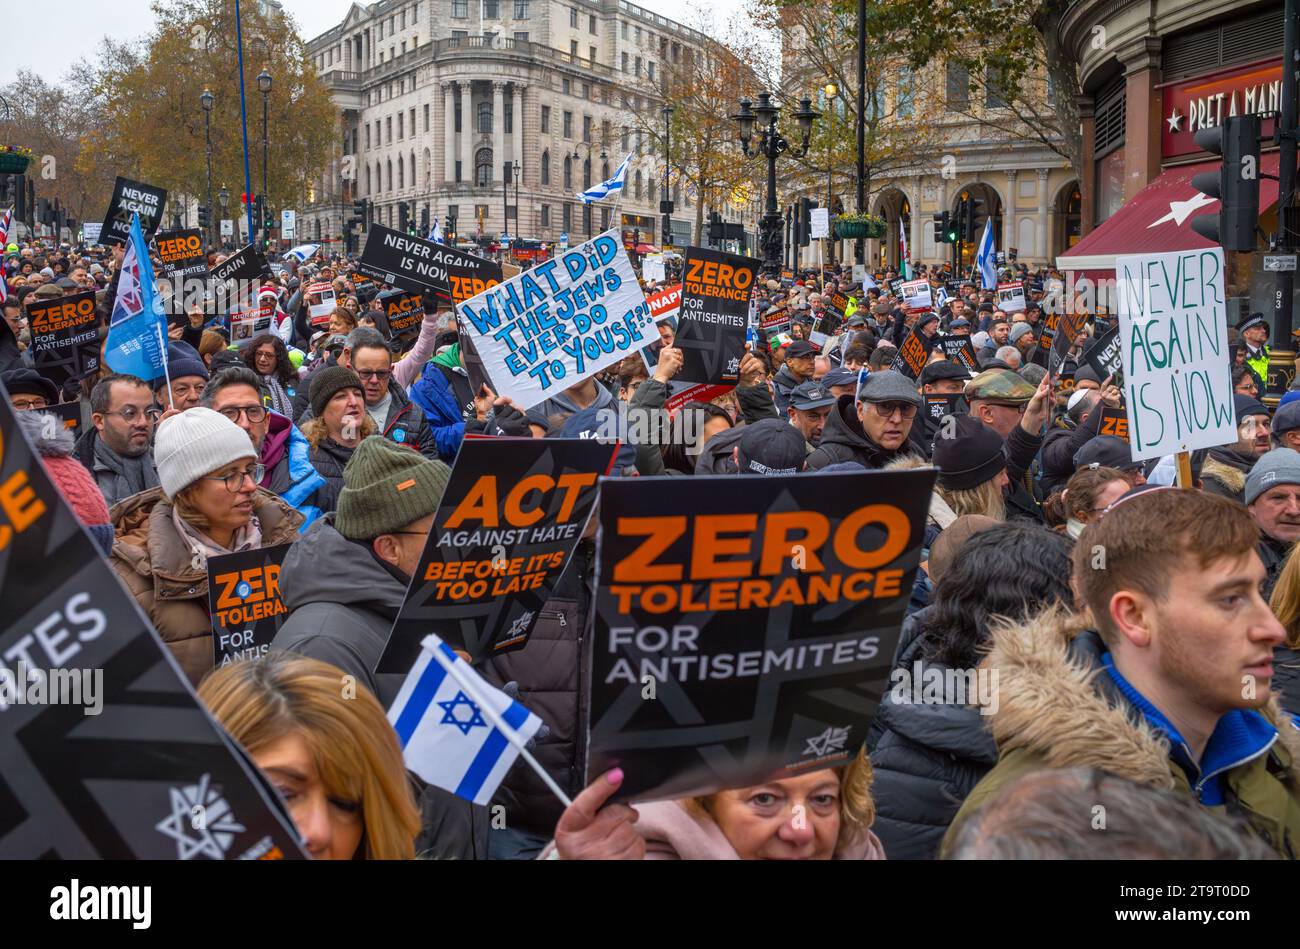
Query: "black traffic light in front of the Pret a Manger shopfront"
1192 114 1260 251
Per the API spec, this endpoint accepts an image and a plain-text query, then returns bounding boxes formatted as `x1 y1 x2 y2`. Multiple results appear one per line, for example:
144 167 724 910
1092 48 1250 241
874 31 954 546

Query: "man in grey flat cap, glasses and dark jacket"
809 369 922 471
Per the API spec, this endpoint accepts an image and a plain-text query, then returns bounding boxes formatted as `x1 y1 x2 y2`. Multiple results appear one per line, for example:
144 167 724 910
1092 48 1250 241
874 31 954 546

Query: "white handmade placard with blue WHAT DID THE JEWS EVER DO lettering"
460 230 658 410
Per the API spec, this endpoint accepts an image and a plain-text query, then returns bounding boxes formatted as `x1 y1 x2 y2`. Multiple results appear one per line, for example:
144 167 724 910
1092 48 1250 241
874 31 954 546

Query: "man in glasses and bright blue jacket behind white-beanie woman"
202 365 325 530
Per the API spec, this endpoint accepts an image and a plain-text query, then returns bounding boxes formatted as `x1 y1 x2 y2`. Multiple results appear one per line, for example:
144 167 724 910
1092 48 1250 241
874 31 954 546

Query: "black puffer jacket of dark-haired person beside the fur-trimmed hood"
867 607 997 859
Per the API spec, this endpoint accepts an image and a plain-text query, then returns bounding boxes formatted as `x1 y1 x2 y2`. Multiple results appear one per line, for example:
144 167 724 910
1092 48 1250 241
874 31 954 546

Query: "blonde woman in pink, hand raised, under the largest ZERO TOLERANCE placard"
541 751 885 861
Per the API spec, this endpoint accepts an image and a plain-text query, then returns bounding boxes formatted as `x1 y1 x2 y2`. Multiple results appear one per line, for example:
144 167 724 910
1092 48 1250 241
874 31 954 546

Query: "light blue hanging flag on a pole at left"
104 213 166 382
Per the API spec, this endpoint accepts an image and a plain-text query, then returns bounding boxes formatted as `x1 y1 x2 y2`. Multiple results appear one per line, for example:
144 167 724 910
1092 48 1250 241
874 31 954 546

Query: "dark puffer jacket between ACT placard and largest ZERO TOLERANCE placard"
481 541 595 840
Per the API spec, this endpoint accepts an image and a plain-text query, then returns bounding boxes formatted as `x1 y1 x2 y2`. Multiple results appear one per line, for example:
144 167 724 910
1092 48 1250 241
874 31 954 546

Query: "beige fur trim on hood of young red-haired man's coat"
982 608 1300 789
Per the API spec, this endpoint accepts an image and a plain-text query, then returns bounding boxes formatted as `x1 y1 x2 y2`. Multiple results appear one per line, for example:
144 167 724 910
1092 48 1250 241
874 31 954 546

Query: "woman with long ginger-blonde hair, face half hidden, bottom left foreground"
199 653 420 861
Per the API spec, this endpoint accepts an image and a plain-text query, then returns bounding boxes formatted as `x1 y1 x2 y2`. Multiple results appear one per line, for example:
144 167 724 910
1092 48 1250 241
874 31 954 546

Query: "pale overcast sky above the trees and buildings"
0 0 744 86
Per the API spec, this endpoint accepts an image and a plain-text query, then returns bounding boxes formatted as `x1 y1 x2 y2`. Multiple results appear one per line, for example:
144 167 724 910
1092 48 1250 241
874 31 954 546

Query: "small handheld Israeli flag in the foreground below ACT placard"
389 634 542 805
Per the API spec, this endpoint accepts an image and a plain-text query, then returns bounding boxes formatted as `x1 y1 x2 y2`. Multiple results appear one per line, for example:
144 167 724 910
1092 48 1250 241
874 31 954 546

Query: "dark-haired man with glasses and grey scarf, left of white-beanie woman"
75 373 161 507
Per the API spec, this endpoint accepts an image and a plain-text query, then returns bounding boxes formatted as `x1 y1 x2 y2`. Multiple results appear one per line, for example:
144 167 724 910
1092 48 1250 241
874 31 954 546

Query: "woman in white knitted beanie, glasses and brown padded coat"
112 406 303 685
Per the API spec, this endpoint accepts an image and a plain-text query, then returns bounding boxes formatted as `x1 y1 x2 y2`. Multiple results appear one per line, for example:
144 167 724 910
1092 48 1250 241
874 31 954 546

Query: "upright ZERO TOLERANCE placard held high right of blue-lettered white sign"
675 247 759 386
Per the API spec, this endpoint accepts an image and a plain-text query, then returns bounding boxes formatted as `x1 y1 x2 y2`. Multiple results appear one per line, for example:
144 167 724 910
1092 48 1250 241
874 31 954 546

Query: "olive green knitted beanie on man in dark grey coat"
334 436 451 541
